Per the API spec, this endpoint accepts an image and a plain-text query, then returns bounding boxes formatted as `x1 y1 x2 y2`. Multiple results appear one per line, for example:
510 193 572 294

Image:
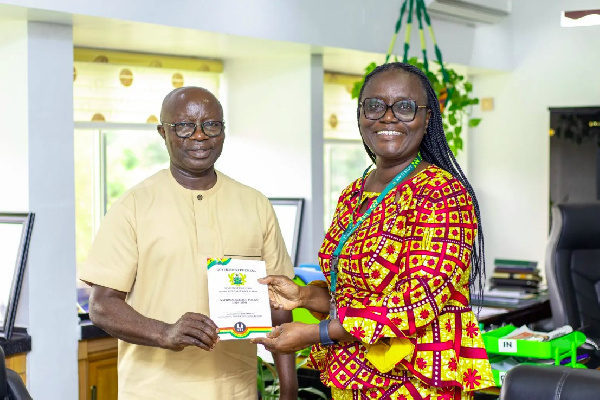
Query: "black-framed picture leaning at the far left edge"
0 212 34 339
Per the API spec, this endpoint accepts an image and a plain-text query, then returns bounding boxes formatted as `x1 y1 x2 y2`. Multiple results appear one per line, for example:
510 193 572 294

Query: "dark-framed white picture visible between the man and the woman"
269 198 304 266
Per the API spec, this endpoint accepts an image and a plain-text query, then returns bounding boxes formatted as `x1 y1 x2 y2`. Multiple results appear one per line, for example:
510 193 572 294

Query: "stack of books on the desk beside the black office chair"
490 259 542 293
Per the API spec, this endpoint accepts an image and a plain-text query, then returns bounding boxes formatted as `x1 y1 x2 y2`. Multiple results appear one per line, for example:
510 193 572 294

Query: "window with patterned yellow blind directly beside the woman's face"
323 72 371 230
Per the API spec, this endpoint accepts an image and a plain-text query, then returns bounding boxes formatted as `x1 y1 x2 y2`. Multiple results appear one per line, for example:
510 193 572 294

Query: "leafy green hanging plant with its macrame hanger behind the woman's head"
352 0 481 156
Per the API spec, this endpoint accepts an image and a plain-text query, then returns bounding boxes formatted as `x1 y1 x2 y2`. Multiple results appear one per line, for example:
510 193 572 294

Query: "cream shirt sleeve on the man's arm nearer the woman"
263 199 295 279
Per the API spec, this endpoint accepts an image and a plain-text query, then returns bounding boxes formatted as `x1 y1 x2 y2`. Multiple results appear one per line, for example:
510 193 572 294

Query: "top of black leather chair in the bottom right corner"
500 364 600 400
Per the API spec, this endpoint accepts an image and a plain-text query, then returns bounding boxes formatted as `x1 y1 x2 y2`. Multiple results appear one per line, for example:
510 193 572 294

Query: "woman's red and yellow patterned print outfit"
310 166 494 399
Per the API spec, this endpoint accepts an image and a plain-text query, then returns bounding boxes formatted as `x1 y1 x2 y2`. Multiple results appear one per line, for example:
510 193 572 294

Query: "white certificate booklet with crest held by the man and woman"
207 258 272 340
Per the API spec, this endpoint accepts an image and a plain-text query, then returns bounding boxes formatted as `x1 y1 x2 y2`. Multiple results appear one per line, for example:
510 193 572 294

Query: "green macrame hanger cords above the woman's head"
385 0 454 110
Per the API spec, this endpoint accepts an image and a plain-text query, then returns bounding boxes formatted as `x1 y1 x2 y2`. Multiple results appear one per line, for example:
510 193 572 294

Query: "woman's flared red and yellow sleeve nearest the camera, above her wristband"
337 180 477 344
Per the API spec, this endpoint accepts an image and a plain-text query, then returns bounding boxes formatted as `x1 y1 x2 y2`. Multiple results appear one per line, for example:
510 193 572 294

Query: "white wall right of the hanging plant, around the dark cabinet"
469 0 600 272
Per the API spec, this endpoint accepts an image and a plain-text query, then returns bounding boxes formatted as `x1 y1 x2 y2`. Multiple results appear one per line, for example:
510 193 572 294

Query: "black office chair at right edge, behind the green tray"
546 203 600 342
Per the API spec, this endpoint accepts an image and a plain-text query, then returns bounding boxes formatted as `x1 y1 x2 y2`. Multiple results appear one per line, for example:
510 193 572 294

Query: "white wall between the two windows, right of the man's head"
217 53 323 263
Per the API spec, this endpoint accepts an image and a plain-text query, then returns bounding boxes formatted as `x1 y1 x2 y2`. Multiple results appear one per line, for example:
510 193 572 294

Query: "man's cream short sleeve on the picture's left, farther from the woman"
77 194 138 292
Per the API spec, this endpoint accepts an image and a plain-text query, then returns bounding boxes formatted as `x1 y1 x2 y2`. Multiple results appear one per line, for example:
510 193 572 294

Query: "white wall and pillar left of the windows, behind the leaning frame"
0 21 79 400
